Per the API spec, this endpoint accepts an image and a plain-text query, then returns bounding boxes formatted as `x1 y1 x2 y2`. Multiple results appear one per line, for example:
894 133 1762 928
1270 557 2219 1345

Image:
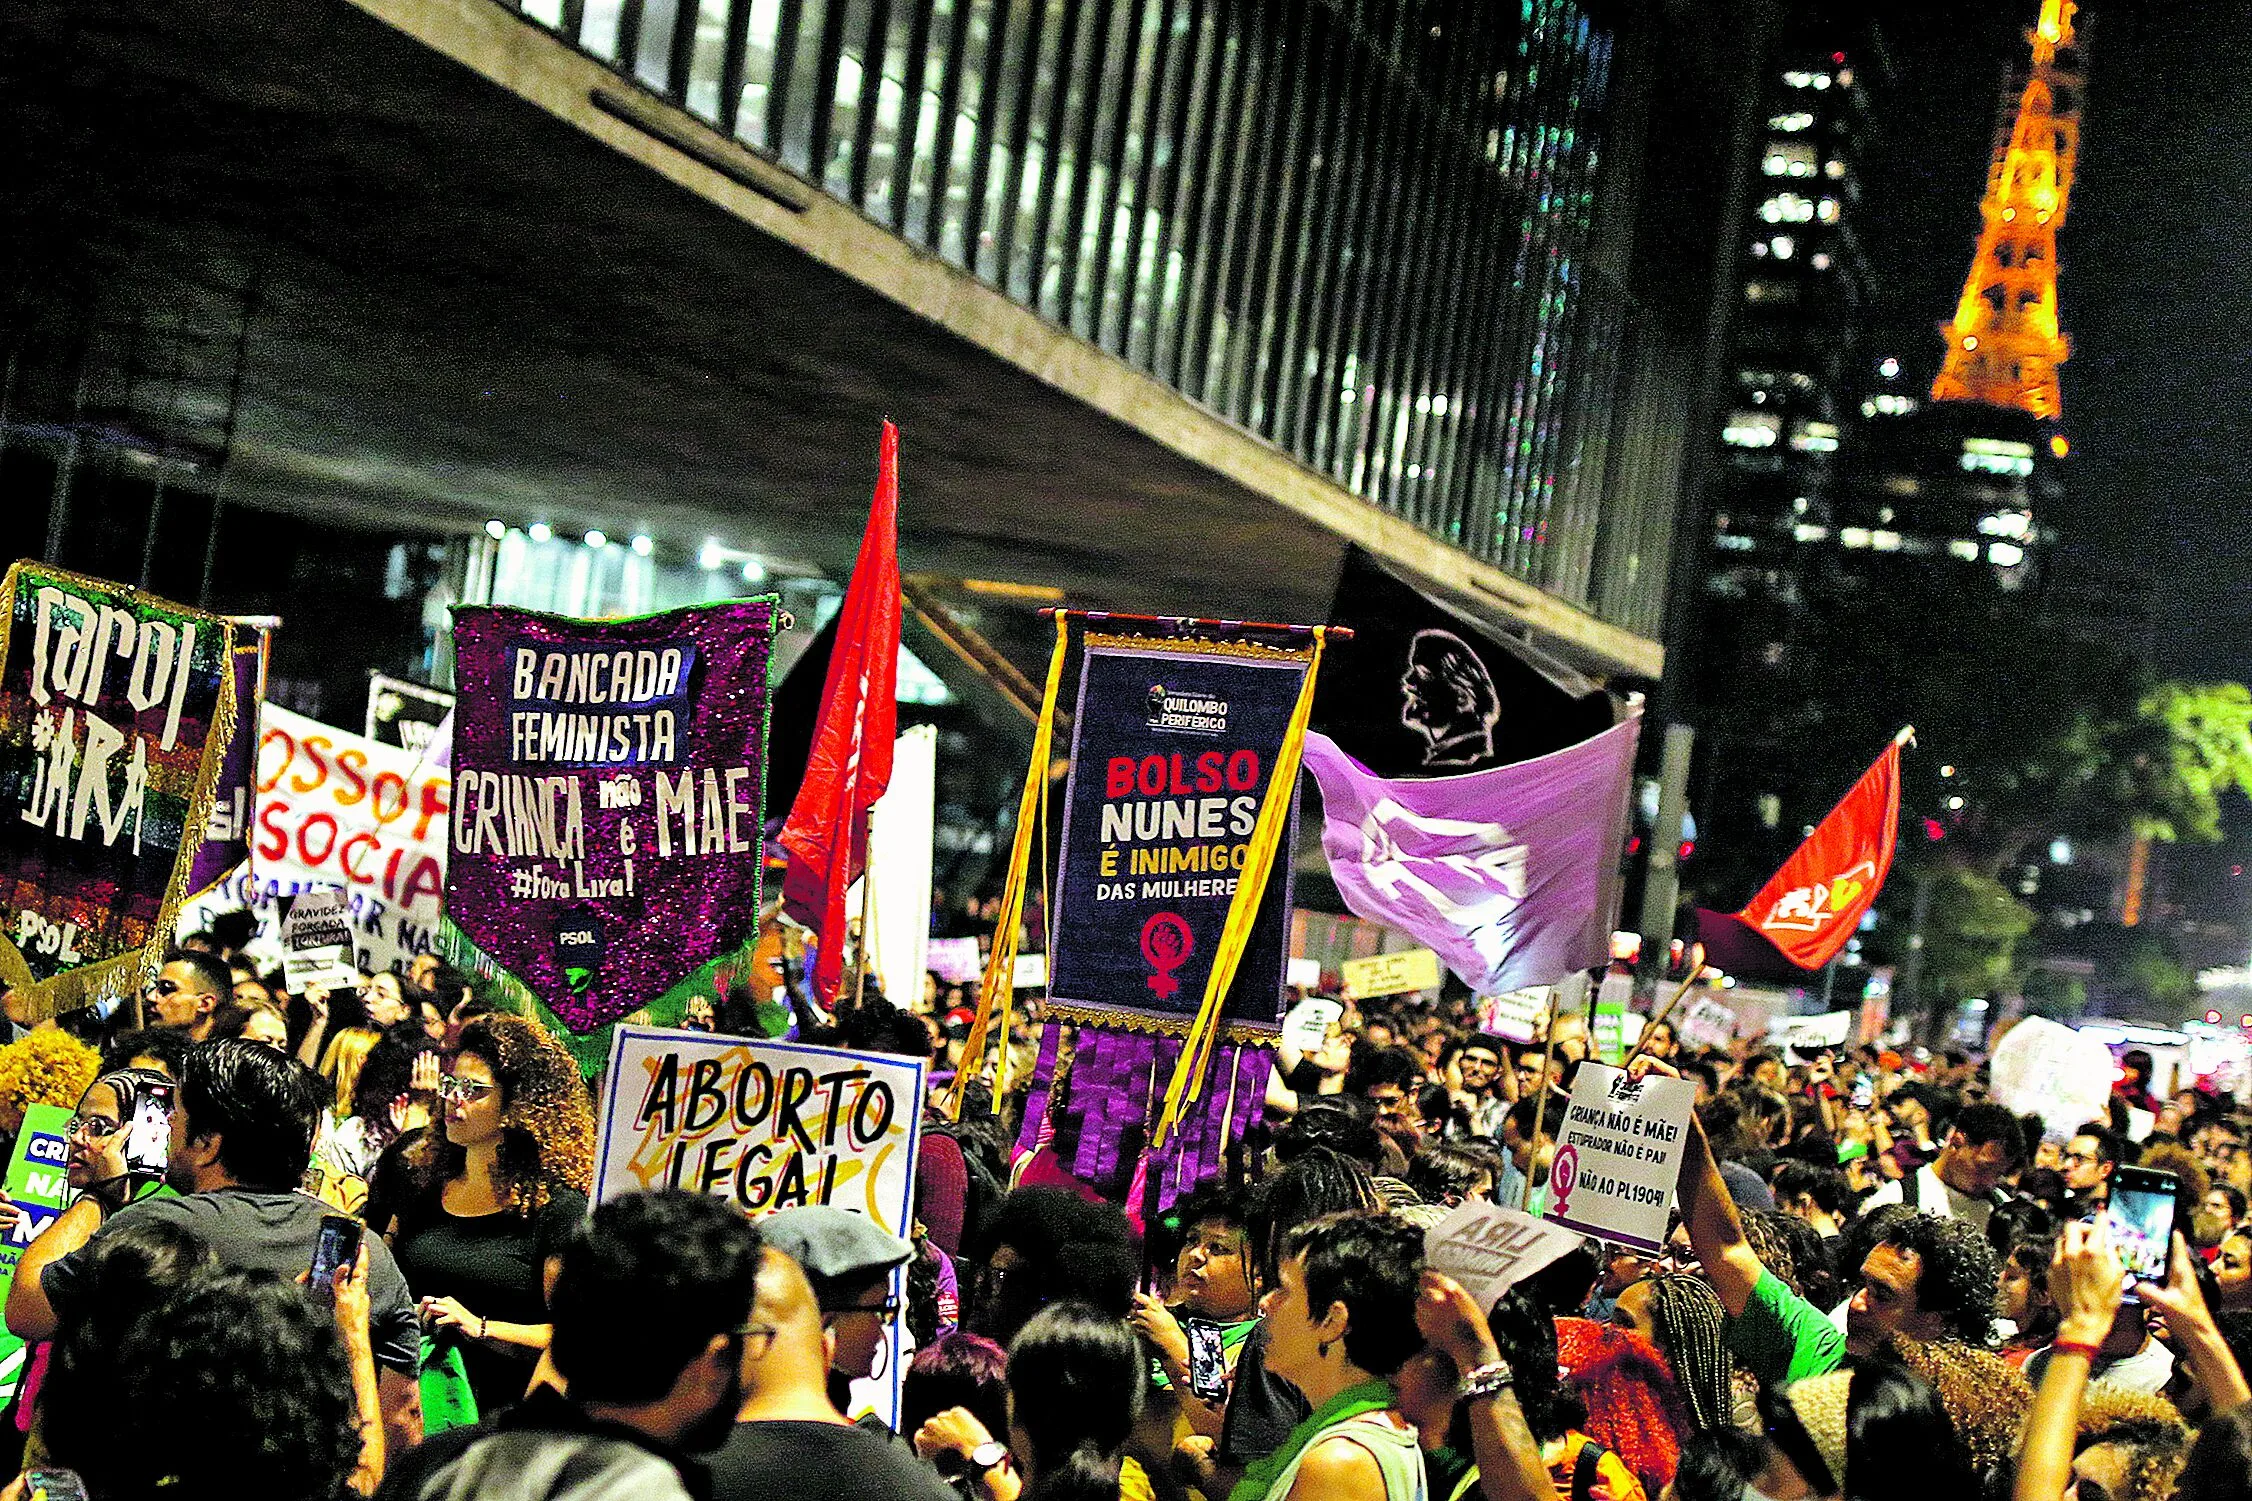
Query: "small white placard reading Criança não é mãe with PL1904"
1547 1060 1696 1251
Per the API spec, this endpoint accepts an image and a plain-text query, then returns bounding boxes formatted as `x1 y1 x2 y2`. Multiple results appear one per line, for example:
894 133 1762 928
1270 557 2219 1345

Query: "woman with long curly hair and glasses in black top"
392 1015 595 1413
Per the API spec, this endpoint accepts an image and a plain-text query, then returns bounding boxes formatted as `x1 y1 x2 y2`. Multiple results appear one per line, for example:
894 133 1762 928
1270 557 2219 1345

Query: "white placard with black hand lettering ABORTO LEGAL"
595 1026 923 1420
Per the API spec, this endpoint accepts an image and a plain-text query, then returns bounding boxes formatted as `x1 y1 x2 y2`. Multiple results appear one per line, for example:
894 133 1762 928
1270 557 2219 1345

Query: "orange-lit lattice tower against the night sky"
1932 0 2081 423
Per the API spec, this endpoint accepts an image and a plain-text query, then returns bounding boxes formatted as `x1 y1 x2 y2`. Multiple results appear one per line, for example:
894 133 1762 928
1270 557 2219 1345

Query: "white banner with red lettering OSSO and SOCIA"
243 704 453 968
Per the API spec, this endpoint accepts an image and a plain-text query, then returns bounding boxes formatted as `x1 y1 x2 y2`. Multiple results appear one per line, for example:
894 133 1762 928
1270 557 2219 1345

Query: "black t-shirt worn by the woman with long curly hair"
392 1188 586 1415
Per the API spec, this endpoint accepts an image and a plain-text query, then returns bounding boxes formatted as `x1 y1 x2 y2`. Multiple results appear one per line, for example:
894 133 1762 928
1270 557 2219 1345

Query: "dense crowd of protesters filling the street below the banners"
0 941 2252 1501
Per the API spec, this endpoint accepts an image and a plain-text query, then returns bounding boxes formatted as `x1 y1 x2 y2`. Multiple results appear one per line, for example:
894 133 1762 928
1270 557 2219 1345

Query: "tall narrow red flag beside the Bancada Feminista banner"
781 423 899 1004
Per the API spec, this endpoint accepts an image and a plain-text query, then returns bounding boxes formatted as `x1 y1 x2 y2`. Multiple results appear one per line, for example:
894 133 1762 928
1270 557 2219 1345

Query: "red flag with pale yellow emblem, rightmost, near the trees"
1736 731 1905 970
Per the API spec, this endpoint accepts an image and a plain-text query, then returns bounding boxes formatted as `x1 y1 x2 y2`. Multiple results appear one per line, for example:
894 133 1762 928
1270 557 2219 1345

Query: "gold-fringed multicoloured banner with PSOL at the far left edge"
0 563 234 1022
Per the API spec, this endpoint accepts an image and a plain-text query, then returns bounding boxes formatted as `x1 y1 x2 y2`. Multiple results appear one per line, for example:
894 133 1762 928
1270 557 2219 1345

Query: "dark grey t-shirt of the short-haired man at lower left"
38 1188 421 1375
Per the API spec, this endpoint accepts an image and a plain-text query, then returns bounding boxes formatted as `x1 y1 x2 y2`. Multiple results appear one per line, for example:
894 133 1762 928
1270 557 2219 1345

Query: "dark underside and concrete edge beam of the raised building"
0 0 1662 677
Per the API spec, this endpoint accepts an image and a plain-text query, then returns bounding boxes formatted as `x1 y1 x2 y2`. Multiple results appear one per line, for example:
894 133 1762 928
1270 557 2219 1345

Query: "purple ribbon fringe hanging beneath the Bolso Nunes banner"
1016 1024 1272 1213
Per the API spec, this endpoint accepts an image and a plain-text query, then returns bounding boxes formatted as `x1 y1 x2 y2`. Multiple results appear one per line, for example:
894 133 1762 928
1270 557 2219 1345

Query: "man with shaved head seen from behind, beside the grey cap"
709 1242 959 1501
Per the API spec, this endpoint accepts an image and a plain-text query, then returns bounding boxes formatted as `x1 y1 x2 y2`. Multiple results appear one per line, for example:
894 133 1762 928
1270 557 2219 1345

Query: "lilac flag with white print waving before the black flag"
1306 707 1642 995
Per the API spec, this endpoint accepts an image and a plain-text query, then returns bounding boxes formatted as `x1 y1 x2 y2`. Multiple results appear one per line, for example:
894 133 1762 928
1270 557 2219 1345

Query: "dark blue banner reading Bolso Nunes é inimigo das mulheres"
1047 637 1306 1026
